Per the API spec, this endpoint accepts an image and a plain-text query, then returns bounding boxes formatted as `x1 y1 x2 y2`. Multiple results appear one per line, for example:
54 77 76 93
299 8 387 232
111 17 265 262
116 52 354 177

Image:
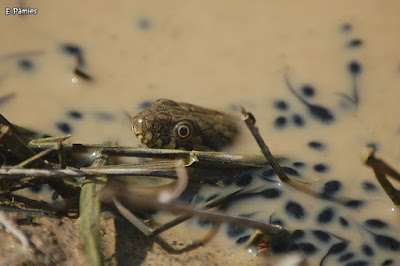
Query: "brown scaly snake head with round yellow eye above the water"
132 99 238 151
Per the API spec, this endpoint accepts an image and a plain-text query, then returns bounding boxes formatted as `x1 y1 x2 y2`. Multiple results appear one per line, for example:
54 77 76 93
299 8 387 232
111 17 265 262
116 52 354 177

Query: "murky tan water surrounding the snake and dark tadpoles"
0 1 400 265
